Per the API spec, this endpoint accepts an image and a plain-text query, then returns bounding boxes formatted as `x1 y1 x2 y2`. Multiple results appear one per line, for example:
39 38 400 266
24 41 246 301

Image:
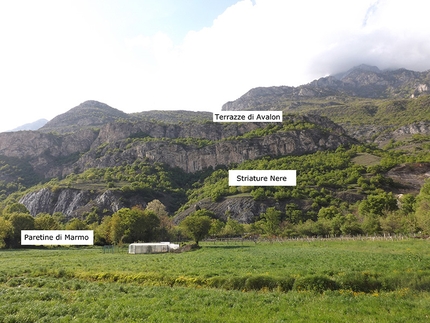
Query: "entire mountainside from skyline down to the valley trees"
0 65 430 228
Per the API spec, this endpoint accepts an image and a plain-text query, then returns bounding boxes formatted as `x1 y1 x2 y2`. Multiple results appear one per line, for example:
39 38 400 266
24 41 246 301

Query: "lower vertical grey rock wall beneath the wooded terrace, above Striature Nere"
70 123 355 176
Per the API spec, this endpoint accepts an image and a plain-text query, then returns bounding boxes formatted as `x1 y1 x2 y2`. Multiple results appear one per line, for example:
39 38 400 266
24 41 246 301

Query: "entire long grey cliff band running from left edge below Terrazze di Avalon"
0 115 352 178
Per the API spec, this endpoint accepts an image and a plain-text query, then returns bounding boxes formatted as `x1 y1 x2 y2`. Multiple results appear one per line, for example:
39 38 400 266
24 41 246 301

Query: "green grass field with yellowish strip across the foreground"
0 239 430 323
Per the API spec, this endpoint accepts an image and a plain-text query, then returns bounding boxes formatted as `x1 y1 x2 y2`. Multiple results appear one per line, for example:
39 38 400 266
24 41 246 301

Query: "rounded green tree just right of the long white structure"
181 209 214 245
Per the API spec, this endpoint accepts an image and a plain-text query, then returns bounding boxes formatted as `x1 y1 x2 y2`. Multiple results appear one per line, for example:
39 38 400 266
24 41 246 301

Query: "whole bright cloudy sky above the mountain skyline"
0 0 430 131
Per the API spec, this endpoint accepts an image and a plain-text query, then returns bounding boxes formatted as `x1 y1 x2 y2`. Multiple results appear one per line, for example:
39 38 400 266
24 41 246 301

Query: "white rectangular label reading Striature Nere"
228 170 297 186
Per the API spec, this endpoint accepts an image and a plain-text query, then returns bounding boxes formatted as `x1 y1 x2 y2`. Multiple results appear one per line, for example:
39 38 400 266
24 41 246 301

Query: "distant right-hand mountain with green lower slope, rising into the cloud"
222 65 430 145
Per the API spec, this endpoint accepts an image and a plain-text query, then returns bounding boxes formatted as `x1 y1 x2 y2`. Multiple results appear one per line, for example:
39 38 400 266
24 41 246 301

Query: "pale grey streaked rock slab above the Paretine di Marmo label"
19 188 146 217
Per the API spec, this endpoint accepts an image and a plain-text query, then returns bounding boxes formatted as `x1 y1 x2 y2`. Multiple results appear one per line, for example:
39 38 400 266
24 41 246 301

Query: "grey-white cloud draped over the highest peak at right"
311 0 430 73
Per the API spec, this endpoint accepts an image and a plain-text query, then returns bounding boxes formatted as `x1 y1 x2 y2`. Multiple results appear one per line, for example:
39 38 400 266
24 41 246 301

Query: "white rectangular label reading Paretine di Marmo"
21 230 94 246
